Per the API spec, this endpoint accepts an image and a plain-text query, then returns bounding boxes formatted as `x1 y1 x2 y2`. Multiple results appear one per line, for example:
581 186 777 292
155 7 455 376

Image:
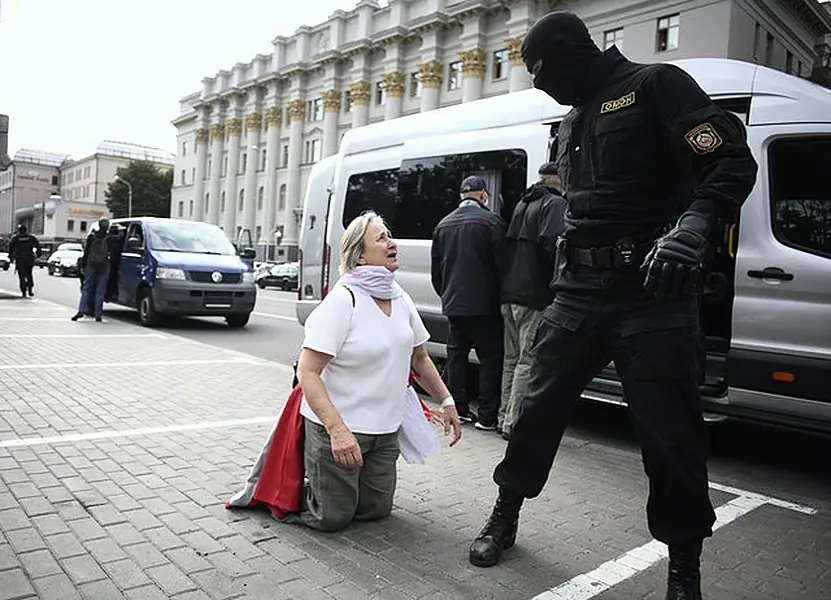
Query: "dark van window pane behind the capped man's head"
392 150 528 240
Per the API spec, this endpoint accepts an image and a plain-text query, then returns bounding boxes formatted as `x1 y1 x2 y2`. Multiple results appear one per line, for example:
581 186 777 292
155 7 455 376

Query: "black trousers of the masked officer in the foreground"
494 267 716 544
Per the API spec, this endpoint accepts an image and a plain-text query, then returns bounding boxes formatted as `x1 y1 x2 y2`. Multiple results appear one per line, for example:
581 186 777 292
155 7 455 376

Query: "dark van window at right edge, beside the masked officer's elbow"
768 136 831 258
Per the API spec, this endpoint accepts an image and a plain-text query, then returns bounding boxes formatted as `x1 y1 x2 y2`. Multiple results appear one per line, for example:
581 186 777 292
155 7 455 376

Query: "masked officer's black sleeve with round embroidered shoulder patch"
645 64 758 224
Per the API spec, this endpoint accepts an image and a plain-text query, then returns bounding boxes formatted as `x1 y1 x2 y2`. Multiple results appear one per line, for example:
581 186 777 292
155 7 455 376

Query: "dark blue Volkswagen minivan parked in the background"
93 217 257 327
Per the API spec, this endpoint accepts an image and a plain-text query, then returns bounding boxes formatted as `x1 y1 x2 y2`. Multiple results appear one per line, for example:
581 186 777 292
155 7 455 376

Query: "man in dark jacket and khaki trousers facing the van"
497 163 566 440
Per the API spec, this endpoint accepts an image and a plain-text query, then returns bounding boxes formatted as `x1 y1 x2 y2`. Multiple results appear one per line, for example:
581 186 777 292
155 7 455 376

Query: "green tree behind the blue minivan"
104 160 173 219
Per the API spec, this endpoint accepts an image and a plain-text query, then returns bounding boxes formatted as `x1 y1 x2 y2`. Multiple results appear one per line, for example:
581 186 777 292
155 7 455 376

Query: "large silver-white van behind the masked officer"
297 59 831 432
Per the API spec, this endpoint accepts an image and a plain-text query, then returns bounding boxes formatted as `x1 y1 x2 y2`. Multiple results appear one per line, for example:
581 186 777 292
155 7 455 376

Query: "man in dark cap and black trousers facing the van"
431 175 505 431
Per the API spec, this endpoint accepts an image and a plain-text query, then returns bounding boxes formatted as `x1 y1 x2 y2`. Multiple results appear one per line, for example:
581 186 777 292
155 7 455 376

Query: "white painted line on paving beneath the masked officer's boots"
531 483 817 600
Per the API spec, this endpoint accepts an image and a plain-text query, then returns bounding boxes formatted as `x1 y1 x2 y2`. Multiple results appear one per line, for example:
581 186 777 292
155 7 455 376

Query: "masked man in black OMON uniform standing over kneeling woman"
470 12 757 600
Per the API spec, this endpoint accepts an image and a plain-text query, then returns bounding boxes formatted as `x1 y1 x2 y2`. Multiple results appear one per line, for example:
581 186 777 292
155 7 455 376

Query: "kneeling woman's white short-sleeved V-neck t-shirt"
300 285 430 435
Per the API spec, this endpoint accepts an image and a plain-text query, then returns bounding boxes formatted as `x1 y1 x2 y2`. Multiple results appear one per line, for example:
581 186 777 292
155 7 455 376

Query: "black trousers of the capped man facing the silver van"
447 313 504 423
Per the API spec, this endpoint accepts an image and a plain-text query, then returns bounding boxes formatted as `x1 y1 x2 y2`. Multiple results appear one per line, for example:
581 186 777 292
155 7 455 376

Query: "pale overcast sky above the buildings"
0 0 354 158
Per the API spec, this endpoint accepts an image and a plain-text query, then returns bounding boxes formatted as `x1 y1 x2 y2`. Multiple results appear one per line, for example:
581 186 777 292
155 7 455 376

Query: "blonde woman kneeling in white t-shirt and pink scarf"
287 212 461 531
